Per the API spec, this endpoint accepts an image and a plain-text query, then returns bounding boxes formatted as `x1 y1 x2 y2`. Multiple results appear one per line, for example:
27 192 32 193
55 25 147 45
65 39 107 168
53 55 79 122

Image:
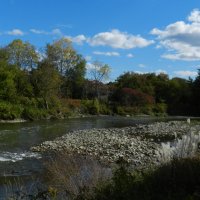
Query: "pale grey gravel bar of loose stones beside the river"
31 121 200 166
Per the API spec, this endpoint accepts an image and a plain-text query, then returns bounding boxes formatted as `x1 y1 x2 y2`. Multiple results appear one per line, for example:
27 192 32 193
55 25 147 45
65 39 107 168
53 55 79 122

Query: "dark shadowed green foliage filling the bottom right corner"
77 158 200 200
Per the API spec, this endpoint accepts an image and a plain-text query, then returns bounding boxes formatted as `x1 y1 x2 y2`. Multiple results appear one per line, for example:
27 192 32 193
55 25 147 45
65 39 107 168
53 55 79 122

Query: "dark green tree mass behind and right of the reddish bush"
112 72 200 115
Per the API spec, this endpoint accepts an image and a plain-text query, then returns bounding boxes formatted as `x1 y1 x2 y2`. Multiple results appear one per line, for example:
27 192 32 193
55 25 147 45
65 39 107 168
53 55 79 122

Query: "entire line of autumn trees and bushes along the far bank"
0 38 200 119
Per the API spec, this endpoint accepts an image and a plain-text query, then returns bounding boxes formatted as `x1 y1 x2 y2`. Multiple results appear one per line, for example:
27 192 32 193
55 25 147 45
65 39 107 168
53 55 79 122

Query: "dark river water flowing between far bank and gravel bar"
0 116 191 199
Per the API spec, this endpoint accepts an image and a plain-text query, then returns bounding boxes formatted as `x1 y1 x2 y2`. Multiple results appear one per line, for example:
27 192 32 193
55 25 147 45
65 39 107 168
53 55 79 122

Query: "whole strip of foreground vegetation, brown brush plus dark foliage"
3 156 200 200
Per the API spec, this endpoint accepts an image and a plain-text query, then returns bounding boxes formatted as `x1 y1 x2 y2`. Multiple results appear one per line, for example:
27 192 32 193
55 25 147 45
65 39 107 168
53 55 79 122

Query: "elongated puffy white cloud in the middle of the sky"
88 29 154 49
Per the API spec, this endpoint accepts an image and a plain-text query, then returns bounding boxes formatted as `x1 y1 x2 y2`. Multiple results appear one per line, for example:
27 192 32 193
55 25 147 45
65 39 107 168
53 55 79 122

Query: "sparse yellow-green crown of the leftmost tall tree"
6 40 39 70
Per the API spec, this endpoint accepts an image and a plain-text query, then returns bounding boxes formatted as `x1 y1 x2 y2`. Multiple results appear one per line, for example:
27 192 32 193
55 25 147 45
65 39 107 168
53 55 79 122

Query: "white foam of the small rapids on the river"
0 151 41 162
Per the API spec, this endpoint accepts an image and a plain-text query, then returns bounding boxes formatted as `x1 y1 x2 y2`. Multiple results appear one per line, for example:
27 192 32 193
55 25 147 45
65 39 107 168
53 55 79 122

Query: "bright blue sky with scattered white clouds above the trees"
0 0 200 81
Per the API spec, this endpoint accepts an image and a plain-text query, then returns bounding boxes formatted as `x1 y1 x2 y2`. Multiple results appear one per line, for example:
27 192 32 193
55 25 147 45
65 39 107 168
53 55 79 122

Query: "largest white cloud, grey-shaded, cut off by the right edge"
151 10 200 61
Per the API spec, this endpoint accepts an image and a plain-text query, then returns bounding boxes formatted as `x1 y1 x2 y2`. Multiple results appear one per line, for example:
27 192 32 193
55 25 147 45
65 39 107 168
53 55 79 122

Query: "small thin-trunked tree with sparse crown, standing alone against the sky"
90 61 111 98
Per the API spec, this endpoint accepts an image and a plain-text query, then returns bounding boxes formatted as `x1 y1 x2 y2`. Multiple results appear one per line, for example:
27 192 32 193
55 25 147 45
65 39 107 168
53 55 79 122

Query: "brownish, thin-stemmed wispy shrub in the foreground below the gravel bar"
45 152 111 199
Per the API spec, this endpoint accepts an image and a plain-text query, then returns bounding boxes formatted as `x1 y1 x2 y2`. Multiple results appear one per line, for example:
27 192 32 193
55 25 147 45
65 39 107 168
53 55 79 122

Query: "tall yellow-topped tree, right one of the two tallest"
46 38 86 98
